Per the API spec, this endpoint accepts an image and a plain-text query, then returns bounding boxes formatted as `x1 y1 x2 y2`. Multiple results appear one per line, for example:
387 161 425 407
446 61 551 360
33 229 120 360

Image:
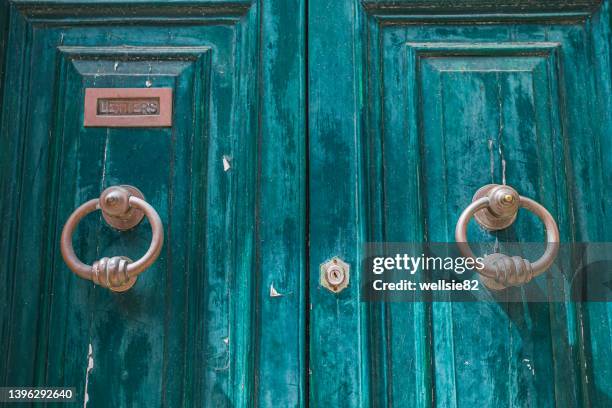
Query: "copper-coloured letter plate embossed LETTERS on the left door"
84 88 172 127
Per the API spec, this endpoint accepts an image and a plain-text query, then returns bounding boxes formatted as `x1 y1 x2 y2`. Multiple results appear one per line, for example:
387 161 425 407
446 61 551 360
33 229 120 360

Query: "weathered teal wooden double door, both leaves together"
0 0 612 407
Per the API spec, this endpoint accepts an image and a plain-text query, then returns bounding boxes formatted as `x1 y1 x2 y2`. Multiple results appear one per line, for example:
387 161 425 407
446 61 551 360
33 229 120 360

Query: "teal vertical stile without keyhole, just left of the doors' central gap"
255 0 308 407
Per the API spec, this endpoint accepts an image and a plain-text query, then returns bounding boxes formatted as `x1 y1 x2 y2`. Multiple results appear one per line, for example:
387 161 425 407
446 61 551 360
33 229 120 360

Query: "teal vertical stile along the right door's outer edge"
573 1 612 406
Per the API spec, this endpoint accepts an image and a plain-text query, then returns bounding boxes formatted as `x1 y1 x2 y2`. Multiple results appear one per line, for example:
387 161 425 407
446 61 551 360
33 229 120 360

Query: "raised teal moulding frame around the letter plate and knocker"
45 46 213 406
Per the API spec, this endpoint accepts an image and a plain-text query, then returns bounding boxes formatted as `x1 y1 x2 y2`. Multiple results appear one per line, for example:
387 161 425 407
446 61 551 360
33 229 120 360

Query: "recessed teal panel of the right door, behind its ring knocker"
370 21 604 406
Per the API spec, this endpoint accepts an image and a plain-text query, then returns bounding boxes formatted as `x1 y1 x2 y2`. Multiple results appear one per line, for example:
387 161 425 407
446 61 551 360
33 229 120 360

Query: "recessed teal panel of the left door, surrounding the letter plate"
7 14 249 405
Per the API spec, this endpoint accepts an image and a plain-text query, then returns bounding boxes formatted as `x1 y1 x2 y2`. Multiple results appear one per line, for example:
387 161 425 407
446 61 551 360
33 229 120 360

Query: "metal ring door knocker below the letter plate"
61 185 164 292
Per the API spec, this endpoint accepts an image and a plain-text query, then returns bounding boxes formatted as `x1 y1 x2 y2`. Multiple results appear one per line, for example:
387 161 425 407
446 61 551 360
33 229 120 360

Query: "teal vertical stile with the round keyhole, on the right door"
308 0 370 407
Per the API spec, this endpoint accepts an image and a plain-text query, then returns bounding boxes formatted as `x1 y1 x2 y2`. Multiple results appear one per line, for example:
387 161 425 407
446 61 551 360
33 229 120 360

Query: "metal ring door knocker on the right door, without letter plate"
455 184 559 290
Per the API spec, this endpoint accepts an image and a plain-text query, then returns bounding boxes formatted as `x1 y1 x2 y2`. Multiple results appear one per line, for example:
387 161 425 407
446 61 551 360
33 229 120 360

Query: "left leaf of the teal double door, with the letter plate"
0 1 305 407
